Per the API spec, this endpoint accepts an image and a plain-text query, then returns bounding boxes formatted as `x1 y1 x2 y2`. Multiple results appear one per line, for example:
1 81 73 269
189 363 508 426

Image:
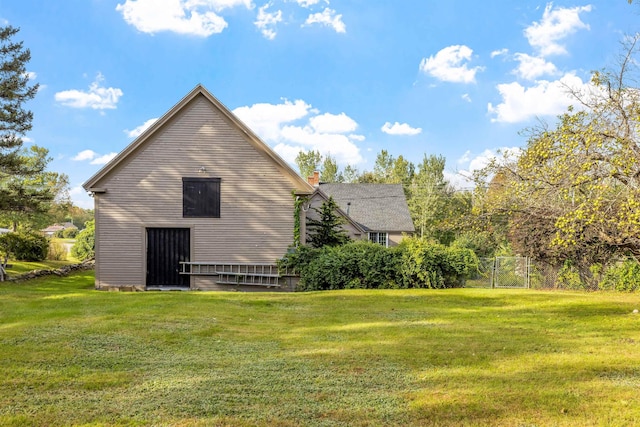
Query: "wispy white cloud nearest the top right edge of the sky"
524 3 591 56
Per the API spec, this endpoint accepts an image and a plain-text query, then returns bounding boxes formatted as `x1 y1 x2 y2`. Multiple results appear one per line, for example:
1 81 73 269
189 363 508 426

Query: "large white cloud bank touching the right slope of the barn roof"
233 100 364 165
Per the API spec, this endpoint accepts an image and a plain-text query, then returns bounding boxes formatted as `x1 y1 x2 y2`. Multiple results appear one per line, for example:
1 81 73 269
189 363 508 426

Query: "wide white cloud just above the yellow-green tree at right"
488 73 590 123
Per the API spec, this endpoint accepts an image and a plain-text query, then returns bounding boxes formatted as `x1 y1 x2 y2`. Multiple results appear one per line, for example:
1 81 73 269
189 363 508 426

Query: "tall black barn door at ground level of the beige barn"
147 228 190 288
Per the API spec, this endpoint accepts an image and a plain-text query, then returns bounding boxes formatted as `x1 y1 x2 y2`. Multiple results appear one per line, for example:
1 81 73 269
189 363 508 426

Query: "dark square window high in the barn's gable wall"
182 178 220 218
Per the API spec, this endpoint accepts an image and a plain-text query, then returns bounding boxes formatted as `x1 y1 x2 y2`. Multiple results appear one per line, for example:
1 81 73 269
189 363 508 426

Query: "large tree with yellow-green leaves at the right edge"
476 35 640 282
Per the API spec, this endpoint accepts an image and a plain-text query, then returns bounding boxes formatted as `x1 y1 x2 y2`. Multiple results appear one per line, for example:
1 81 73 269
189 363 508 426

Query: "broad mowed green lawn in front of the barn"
0 272 640 426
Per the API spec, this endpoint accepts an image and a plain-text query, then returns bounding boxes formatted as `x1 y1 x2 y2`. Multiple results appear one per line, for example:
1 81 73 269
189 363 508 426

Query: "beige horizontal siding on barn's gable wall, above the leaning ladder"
96 97 293 286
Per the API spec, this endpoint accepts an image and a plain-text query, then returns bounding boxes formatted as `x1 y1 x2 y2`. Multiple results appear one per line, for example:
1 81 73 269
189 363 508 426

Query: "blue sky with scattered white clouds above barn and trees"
0 0 640 207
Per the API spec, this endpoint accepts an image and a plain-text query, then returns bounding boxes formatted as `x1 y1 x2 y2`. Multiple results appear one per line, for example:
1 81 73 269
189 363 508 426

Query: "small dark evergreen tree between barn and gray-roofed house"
307 197 351 248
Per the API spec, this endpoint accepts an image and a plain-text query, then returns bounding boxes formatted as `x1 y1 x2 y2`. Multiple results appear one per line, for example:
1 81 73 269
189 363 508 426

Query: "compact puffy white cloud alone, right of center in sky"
420 45 483 83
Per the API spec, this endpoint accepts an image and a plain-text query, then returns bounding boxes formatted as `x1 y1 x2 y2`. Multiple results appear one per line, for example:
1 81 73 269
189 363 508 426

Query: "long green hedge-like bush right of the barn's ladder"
279 239 478 291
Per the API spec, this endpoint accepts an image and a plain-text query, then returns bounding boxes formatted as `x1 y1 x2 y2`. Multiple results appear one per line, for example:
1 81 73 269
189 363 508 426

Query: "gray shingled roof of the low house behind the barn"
319 183 415 233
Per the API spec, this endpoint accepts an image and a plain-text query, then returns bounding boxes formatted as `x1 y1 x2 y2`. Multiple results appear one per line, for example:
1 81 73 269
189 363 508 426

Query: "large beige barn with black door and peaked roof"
83 86 314 290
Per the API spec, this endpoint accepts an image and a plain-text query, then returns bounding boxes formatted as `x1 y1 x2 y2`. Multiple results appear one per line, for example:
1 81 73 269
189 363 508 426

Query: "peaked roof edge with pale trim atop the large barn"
82 84 314 194
